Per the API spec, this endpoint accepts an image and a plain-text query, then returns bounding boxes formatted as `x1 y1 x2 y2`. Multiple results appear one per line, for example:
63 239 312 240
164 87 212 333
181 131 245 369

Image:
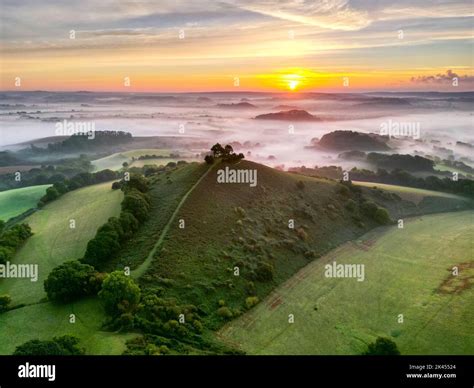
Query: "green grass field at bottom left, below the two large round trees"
0 298 135 355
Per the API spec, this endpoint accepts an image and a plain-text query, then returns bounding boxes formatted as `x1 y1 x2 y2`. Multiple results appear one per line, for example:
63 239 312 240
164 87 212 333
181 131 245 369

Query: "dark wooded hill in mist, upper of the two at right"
317 131 390 151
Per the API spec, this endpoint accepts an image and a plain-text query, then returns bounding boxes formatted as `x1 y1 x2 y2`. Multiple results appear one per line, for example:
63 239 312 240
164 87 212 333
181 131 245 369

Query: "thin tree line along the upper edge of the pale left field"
38 170 119 207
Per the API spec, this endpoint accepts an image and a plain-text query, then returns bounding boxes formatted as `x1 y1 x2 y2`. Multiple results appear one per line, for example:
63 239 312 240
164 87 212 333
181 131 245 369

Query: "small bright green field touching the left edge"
0 185 50 221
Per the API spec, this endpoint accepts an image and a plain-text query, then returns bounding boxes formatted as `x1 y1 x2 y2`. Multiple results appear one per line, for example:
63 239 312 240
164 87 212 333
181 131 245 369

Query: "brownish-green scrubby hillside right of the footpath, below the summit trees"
140 161 386 328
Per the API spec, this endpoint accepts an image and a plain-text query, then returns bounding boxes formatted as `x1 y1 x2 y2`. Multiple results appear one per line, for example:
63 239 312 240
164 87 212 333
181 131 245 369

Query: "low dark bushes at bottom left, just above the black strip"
13 335 84 356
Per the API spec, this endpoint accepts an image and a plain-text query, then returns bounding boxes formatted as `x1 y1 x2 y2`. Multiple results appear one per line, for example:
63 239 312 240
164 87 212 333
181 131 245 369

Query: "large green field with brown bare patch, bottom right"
218 211 474 354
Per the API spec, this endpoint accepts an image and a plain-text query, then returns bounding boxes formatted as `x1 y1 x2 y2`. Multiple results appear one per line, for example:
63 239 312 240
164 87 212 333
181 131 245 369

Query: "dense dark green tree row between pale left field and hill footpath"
82 174 151 268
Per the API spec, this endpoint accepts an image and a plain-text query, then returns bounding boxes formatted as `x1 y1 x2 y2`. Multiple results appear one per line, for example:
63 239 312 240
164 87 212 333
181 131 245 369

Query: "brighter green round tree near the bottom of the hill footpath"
99 271 140 316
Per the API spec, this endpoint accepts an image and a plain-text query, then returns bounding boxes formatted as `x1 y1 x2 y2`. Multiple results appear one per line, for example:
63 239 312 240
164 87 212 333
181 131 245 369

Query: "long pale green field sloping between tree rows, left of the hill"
0 182 123 305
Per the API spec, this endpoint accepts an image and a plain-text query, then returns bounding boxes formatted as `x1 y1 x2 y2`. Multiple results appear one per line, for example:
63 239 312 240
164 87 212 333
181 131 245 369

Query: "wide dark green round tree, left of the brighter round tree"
44 260 100 303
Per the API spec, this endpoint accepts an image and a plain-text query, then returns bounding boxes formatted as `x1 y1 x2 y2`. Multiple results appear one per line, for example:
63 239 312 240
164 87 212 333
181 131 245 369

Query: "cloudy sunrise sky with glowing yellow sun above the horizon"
0 0 474 93
